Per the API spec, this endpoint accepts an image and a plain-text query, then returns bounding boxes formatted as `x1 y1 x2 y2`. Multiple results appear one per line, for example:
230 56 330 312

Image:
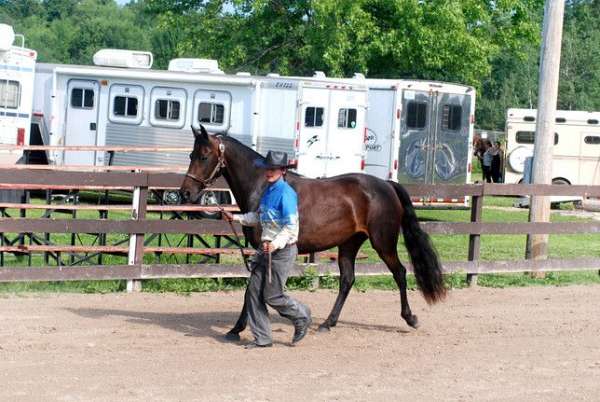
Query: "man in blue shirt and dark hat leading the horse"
223 151 312 349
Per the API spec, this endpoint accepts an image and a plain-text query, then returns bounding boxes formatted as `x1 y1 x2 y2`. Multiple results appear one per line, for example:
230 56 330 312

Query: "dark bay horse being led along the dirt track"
181 126 446 335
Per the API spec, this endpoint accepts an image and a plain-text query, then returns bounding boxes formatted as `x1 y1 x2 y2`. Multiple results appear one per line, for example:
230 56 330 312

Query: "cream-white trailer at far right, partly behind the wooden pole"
504 109 600 187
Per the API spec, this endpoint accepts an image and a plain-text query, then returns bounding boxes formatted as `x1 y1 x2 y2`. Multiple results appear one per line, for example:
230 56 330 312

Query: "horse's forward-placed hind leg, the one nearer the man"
319 233 367 332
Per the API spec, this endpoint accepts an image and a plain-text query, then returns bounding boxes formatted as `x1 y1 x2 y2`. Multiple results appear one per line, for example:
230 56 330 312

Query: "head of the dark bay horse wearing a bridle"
180 125 225 202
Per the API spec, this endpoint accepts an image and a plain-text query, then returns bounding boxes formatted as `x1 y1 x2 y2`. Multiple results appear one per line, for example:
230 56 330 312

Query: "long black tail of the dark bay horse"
389 181 446 304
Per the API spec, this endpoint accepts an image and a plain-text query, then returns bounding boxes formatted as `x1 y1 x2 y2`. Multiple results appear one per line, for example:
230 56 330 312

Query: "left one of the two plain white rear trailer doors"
298 87 330 178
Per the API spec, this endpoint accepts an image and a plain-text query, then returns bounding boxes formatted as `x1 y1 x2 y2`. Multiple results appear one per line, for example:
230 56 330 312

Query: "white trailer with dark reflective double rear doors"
364 79 475 203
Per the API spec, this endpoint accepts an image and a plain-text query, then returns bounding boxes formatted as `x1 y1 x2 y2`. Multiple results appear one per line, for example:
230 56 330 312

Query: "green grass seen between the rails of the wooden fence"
0 197 600 293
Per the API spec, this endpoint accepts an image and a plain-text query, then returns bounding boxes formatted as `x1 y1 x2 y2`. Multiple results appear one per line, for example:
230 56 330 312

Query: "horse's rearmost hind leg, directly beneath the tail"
371 235 419 328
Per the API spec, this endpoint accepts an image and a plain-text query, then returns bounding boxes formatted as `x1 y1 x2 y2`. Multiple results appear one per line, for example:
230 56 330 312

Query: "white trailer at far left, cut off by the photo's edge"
0 24 37 164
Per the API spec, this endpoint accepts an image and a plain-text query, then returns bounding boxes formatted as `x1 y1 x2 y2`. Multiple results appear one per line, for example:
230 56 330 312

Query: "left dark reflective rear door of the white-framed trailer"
398 90 435 183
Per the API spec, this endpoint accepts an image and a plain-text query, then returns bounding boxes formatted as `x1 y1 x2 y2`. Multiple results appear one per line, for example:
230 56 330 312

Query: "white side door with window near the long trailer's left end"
64 80 99 165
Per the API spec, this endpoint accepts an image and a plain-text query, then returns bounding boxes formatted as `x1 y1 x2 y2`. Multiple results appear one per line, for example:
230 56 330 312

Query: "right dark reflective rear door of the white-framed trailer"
429 93 471 184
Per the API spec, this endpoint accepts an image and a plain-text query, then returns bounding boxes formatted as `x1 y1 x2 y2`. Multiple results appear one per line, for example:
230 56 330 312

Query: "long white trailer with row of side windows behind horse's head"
34 50 368 177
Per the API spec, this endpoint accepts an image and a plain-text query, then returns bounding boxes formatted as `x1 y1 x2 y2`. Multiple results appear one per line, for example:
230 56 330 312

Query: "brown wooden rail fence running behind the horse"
0 169 600 289
